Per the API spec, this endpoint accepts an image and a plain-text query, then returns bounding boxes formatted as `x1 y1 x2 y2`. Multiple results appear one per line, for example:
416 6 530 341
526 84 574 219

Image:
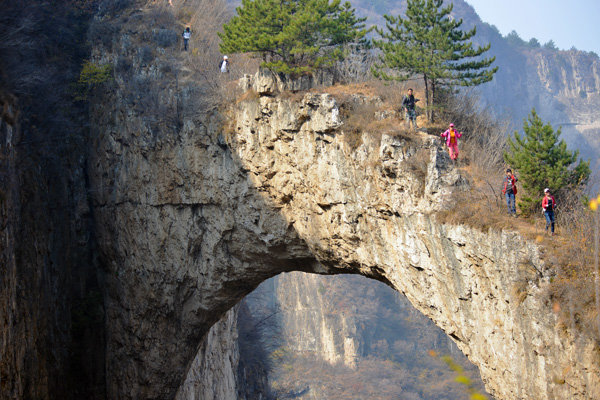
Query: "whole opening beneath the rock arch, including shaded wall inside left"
177 272 493 400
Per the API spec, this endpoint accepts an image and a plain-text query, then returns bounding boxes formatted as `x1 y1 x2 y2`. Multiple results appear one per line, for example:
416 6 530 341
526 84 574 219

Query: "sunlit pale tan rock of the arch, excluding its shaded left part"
232 76 598 399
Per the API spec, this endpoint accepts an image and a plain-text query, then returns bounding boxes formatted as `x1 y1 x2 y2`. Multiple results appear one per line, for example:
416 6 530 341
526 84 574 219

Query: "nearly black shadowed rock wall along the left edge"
0 93 104 399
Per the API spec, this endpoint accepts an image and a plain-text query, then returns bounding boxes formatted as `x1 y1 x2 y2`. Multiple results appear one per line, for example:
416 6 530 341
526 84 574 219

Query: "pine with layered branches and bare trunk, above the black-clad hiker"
372 0 498 122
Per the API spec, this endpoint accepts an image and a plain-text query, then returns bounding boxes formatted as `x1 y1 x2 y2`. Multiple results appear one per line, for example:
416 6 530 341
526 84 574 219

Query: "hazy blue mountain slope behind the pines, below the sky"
352 0 600 170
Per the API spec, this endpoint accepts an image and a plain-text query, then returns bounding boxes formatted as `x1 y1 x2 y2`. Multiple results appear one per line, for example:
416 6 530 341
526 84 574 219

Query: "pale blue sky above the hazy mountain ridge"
465 0 600 55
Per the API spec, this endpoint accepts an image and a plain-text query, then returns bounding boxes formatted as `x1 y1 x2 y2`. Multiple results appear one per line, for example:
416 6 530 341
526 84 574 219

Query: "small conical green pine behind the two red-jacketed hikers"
504 108 591 214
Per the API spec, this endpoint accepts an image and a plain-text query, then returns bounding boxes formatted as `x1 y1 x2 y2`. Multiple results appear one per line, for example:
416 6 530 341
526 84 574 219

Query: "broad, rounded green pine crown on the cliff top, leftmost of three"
218 0 367 74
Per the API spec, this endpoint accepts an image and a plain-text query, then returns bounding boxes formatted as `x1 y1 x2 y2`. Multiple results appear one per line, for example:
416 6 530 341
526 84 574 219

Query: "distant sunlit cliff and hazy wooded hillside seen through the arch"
244 272 484 400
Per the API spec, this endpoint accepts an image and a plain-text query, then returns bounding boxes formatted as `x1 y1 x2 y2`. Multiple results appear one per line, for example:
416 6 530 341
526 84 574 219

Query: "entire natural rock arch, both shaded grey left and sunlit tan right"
90 66 599 399
